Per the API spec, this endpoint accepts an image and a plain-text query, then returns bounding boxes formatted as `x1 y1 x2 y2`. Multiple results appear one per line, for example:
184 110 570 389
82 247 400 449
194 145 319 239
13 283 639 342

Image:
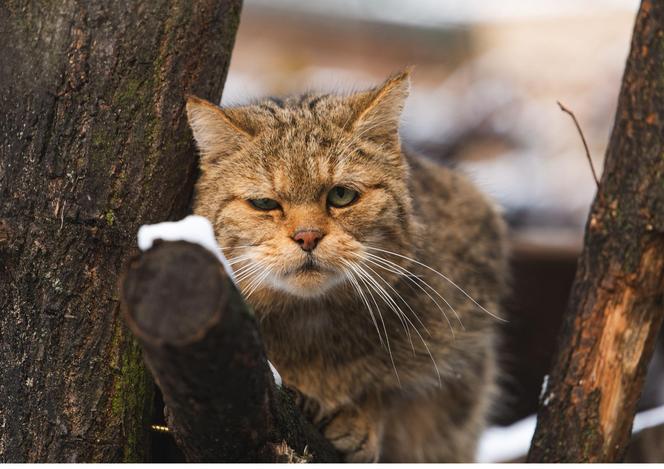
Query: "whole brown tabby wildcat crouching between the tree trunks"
187 72 507 462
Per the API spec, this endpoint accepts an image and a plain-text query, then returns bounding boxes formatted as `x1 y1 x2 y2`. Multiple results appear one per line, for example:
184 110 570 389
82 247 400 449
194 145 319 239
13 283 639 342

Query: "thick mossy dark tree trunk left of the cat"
0 0 241 462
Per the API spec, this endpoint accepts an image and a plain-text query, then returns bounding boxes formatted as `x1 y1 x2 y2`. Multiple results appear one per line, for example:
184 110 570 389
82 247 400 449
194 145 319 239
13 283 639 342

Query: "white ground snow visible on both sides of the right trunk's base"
476 400 664 462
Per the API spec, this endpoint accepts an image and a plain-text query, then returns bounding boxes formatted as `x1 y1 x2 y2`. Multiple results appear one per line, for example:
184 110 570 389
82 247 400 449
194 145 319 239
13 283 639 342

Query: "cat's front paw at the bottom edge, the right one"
322 408 380 462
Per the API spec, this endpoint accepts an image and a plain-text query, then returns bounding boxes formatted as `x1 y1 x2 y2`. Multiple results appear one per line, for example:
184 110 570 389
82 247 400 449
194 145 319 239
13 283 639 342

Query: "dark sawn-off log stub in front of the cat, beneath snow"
121 241 339 462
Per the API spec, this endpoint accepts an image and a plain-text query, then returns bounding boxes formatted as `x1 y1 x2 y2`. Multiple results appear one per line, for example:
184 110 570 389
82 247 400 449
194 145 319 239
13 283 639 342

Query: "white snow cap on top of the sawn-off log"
138 215 235 283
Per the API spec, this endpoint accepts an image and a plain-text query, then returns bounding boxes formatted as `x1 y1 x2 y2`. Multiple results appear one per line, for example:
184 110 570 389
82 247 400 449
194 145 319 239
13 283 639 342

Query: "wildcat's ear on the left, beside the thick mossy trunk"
187 96 253 164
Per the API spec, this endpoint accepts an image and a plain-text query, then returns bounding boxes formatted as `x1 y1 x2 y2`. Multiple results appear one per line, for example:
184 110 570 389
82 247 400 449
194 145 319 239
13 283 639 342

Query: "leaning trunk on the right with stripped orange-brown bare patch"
528 0 664 462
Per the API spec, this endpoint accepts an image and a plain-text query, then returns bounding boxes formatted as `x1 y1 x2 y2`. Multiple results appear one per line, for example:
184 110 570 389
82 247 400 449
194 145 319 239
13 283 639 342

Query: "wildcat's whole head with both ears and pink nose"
187 73 411 298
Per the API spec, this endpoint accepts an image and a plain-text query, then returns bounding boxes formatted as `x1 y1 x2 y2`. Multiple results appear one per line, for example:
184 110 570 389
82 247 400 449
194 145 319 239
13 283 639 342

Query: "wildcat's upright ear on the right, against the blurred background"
349 68 410 146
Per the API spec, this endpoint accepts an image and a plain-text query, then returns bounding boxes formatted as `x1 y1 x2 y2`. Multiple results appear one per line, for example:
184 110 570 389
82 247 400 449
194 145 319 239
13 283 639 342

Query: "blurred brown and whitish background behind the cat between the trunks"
217 0 663 461
